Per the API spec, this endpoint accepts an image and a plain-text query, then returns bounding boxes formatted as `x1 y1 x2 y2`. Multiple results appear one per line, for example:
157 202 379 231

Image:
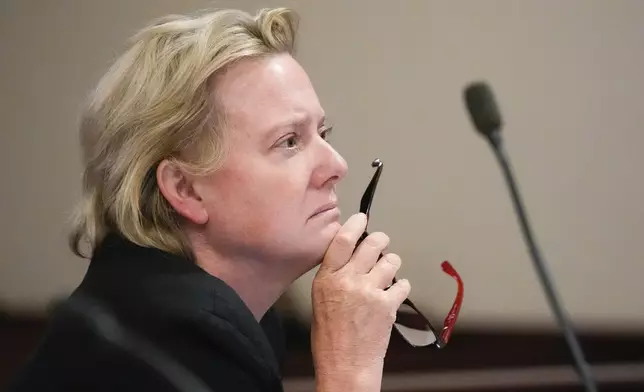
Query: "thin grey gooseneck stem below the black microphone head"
486 130 597 392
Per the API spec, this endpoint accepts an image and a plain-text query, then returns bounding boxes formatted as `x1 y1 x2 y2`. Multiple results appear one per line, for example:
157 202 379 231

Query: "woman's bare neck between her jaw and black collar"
193 234 289 322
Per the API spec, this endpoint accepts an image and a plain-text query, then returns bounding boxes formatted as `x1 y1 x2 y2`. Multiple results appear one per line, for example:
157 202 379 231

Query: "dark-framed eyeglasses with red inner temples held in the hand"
358 159 463 348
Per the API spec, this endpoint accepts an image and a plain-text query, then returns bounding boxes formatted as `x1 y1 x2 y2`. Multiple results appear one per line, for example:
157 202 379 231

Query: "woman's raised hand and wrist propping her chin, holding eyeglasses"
311 214 411 392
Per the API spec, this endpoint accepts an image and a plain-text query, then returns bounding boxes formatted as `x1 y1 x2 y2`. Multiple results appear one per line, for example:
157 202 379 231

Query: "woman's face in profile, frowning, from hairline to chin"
195 54 347 275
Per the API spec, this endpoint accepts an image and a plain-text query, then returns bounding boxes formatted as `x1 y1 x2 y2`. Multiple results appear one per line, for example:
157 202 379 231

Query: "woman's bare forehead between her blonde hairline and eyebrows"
214 54 324 136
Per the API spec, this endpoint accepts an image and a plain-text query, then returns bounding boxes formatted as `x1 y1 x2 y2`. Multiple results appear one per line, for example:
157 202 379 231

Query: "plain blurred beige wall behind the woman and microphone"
0 0 644 329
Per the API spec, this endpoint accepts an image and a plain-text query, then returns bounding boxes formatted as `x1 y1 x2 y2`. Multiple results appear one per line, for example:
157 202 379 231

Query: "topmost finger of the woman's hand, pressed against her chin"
320 213 367 271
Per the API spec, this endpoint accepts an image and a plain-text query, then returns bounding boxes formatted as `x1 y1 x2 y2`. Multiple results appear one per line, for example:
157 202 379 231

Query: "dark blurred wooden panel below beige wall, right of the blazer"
285 316 644 376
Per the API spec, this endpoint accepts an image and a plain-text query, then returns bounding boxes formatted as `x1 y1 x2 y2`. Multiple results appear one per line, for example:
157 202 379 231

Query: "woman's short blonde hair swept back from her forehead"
69 8 298 257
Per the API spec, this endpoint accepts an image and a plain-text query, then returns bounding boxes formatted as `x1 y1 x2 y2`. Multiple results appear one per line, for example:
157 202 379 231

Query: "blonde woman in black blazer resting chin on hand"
12 9 410 392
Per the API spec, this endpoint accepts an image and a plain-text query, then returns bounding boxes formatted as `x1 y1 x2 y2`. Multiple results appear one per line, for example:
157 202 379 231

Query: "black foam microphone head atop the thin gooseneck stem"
463 82 503 136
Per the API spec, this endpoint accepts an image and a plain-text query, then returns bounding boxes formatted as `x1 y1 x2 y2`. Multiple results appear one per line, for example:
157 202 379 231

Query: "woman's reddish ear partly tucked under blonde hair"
156 159 208 225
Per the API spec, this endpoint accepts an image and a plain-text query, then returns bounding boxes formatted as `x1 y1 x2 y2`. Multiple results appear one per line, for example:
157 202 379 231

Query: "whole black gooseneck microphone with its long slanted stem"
463 82 597 392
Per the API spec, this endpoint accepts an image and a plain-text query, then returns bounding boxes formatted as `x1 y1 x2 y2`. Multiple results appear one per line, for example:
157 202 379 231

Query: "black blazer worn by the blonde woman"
9 235 285 392
